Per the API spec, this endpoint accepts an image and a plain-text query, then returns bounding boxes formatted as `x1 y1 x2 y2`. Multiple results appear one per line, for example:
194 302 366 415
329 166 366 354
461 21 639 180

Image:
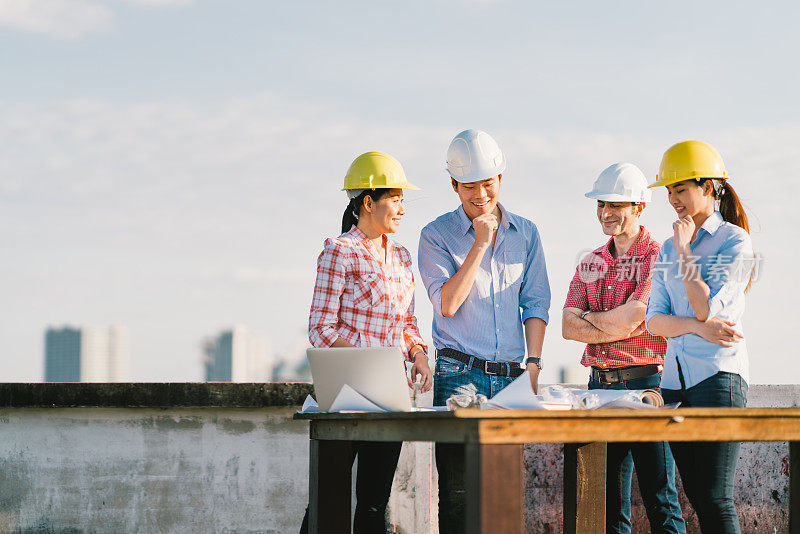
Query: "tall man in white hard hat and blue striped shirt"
419 130 550 533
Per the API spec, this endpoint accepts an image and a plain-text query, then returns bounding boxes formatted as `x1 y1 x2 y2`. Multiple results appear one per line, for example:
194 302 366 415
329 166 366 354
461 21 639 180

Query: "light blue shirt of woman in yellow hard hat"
645 211 755 389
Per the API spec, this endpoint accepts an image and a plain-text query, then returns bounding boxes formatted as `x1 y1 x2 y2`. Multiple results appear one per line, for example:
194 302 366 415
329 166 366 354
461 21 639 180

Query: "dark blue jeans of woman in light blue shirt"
663 372 747 534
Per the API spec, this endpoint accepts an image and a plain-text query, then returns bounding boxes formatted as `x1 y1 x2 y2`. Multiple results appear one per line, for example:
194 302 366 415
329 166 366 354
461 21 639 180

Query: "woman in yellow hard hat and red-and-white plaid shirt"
301 152 433 533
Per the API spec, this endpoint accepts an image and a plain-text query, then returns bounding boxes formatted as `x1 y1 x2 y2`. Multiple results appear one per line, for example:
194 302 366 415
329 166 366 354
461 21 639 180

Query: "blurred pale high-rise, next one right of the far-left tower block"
203 326 272 382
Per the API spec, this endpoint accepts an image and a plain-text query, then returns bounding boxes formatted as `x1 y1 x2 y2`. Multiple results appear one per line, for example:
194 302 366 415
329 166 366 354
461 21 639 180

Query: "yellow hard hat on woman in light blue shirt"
650 141 728 187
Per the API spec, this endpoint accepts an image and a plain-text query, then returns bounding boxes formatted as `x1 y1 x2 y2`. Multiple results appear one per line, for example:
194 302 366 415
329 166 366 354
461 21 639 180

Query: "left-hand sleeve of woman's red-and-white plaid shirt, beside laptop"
308 239 348 347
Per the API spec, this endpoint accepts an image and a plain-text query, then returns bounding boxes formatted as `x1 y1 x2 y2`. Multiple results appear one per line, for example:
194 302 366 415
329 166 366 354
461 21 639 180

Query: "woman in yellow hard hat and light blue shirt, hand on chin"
645 141 755 533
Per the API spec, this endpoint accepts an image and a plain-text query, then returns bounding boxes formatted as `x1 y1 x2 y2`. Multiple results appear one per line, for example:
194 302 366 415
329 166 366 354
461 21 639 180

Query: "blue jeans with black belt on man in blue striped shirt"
433 356 514 534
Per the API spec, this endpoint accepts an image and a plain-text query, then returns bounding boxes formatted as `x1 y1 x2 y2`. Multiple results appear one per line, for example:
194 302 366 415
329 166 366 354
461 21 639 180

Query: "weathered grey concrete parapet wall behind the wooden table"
0 384 800 533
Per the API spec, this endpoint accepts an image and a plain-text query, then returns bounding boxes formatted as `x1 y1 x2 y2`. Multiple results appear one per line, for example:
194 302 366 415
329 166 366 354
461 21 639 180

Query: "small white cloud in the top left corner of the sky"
0 0 113 39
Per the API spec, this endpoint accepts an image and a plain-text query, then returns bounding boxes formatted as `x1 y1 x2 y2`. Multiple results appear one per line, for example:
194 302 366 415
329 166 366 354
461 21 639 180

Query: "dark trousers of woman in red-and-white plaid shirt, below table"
300 441 403 534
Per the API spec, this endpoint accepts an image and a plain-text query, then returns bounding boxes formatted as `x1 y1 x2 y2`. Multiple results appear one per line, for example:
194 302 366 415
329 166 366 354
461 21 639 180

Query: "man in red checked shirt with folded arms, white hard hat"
562 163 686 533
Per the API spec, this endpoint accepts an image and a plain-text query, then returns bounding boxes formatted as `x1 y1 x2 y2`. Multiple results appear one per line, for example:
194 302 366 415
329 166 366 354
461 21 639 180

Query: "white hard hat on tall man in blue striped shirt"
447 130 506 183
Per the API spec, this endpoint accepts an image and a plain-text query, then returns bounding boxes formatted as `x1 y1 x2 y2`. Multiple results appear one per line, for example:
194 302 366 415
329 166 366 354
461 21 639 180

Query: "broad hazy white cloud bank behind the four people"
0 93 800 382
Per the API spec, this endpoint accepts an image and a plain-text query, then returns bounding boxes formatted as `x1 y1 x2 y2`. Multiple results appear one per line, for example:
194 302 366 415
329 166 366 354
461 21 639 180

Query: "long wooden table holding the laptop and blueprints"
295 408 800 534
